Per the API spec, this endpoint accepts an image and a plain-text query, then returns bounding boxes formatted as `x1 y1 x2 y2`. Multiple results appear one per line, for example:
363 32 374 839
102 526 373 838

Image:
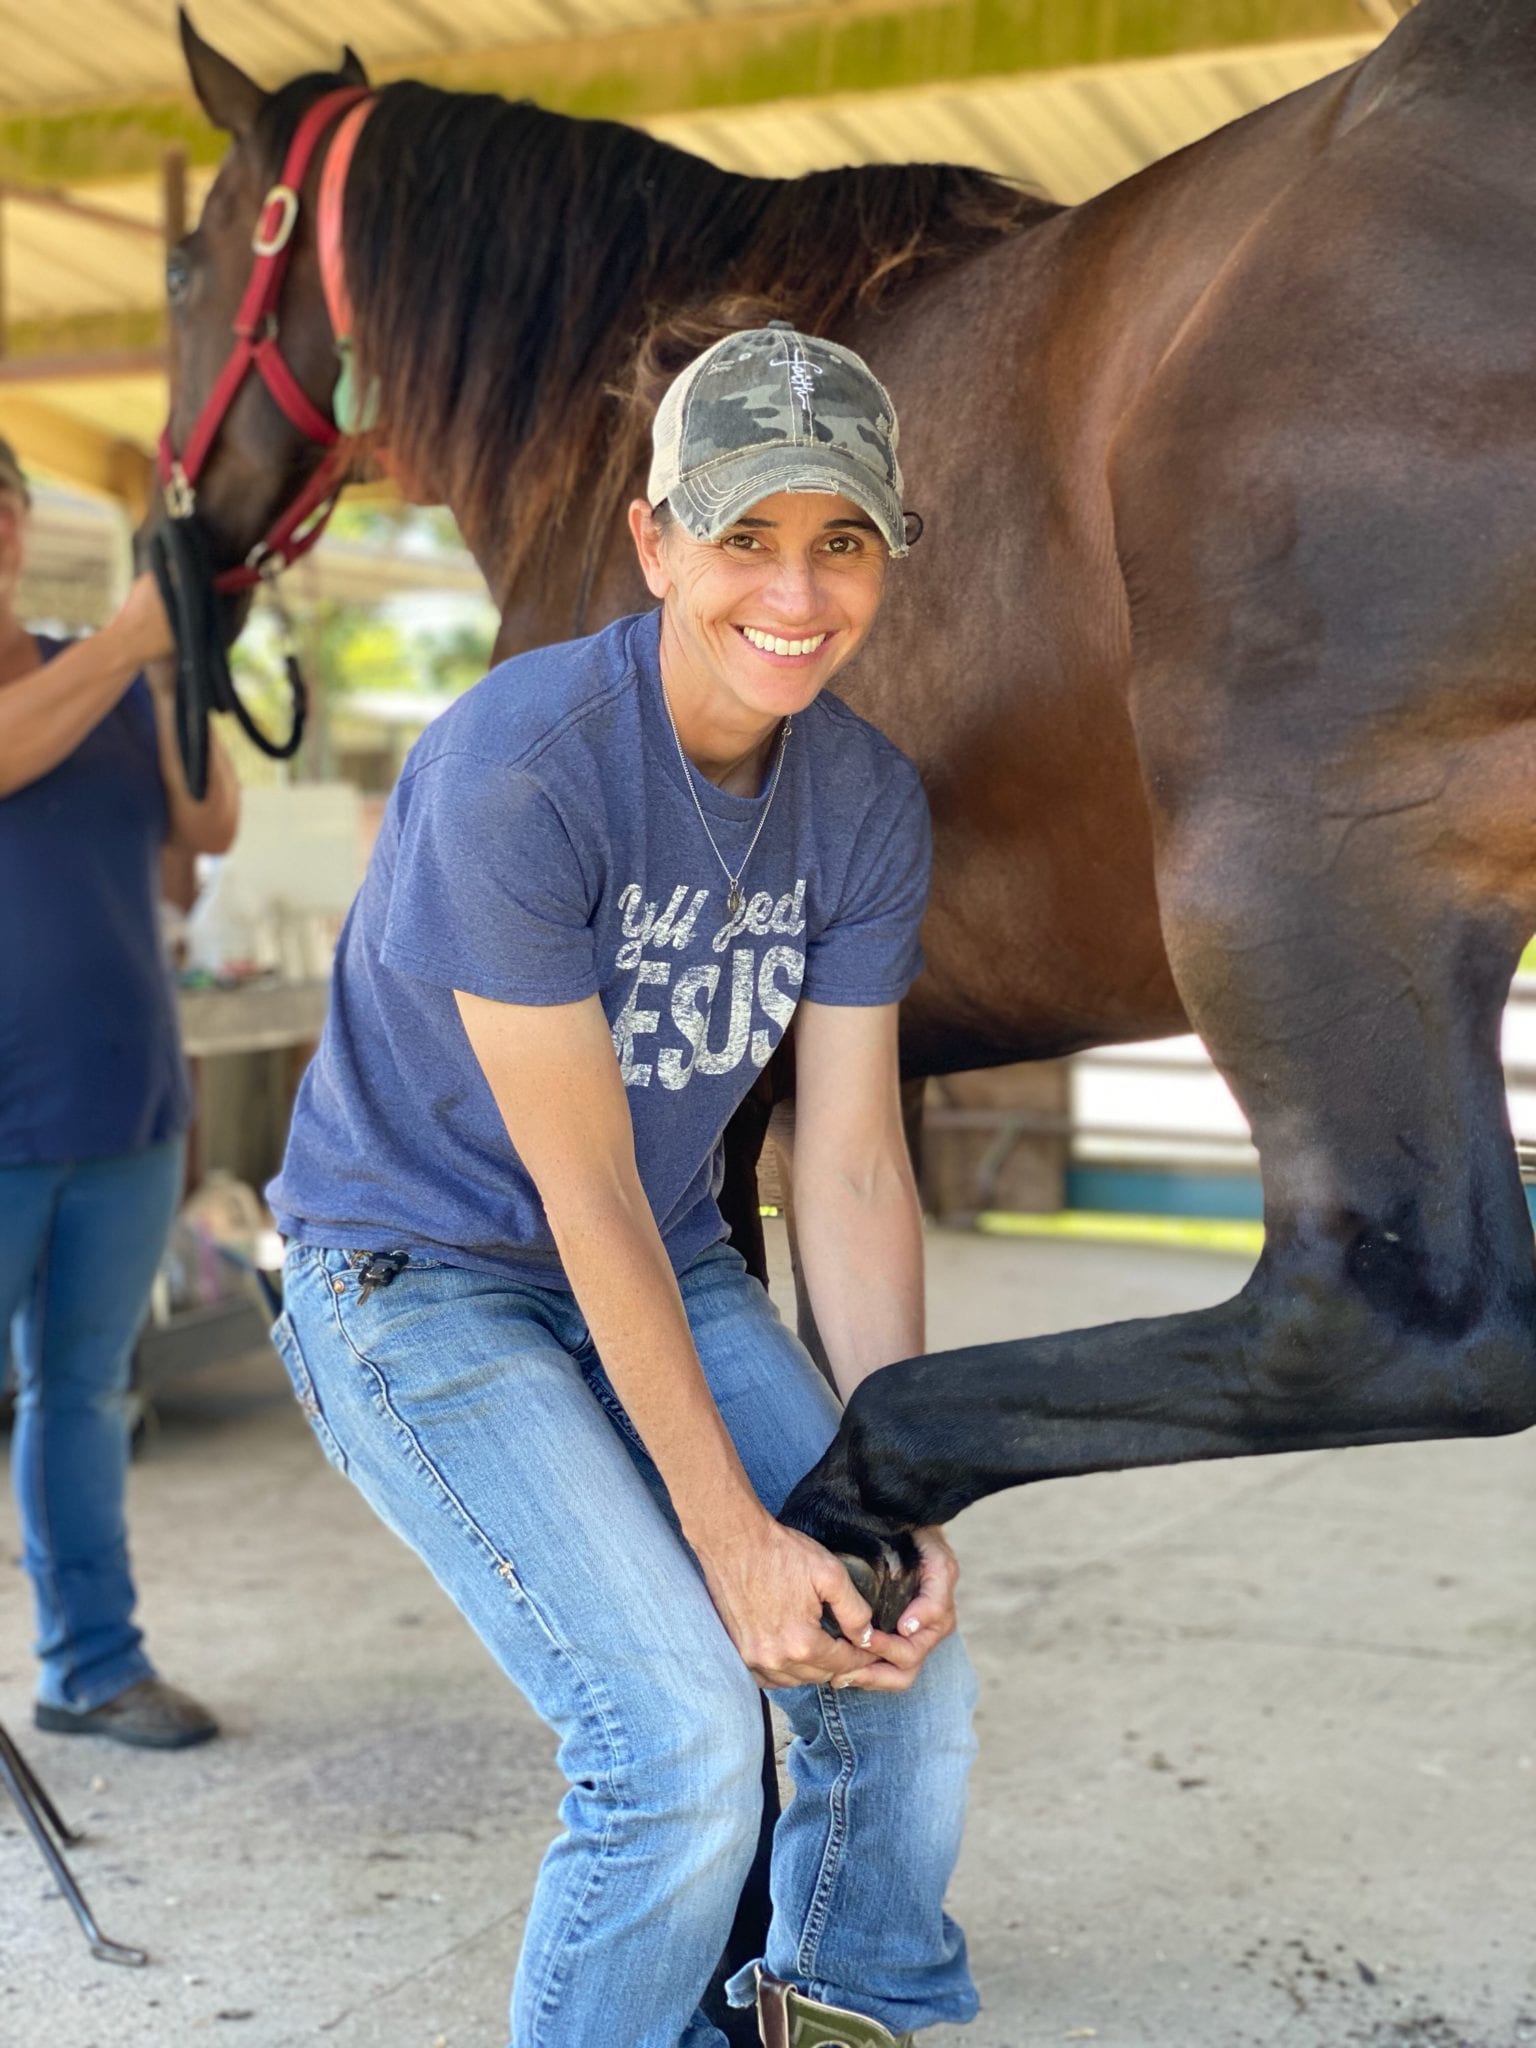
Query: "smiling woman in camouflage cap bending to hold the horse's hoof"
270 324 975 2048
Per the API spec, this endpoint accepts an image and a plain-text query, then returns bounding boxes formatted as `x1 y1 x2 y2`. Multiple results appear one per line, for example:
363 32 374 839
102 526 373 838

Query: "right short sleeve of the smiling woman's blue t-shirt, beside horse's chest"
801 772 932 1008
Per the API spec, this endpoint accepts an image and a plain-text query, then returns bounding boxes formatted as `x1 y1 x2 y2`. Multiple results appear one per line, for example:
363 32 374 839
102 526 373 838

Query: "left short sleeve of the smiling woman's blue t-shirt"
379 754 598 1004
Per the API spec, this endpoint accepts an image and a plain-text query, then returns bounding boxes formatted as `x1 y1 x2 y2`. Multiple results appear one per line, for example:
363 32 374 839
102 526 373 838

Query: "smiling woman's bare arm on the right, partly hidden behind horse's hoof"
793 1001 958 1692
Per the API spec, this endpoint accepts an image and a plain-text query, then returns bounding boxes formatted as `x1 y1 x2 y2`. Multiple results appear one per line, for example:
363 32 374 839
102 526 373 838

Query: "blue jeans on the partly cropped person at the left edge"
0 1139 182 1710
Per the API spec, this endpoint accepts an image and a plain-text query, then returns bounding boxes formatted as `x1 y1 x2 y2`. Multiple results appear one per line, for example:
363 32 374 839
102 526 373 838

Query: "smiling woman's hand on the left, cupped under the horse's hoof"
694 1513 924 1692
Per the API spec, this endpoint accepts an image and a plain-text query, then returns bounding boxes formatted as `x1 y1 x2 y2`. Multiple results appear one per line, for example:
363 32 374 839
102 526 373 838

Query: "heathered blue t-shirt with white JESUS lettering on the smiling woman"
268 612 930 1286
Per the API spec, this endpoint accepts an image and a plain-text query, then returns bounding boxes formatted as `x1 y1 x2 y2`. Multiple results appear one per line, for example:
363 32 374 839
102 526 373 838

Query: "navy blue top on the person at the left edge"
0 635 190 1165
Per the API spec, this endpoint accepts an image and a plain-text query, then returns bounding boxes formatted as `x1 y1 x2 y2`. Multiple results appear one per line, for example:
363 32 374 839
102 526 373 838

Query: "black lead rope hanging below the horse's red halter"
147 512 309 803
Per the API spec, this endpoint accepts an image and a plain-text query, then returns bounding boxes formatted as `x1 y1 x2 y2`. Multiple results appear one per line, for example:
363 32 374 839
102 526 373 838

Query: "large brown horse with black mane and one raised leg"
172 0 1536 1605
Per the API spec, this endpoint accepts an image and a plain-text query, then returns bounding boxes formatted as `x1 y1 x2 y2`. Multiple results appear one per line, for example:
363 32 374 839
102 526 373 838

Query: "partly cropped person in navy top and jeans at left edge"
0 442 238 1749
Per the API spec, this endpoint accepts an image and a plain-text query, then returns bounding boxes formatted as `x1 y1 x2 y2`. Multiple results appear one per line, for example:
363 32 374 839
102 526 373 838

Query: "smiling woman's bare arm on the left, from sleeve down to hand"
455 991 918 1686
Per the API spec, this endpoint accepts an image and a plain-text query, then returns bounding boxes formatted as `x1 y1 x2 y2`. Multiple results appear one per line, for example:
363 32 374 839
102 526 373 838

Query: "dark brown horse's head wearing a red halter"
160 10 367 592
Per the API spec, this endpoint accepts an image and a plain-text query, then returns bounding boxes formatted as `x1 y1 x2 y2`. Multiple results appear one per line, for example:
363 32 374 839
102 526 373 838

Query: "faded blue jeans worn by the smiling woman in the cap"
272 1245 977 2048
